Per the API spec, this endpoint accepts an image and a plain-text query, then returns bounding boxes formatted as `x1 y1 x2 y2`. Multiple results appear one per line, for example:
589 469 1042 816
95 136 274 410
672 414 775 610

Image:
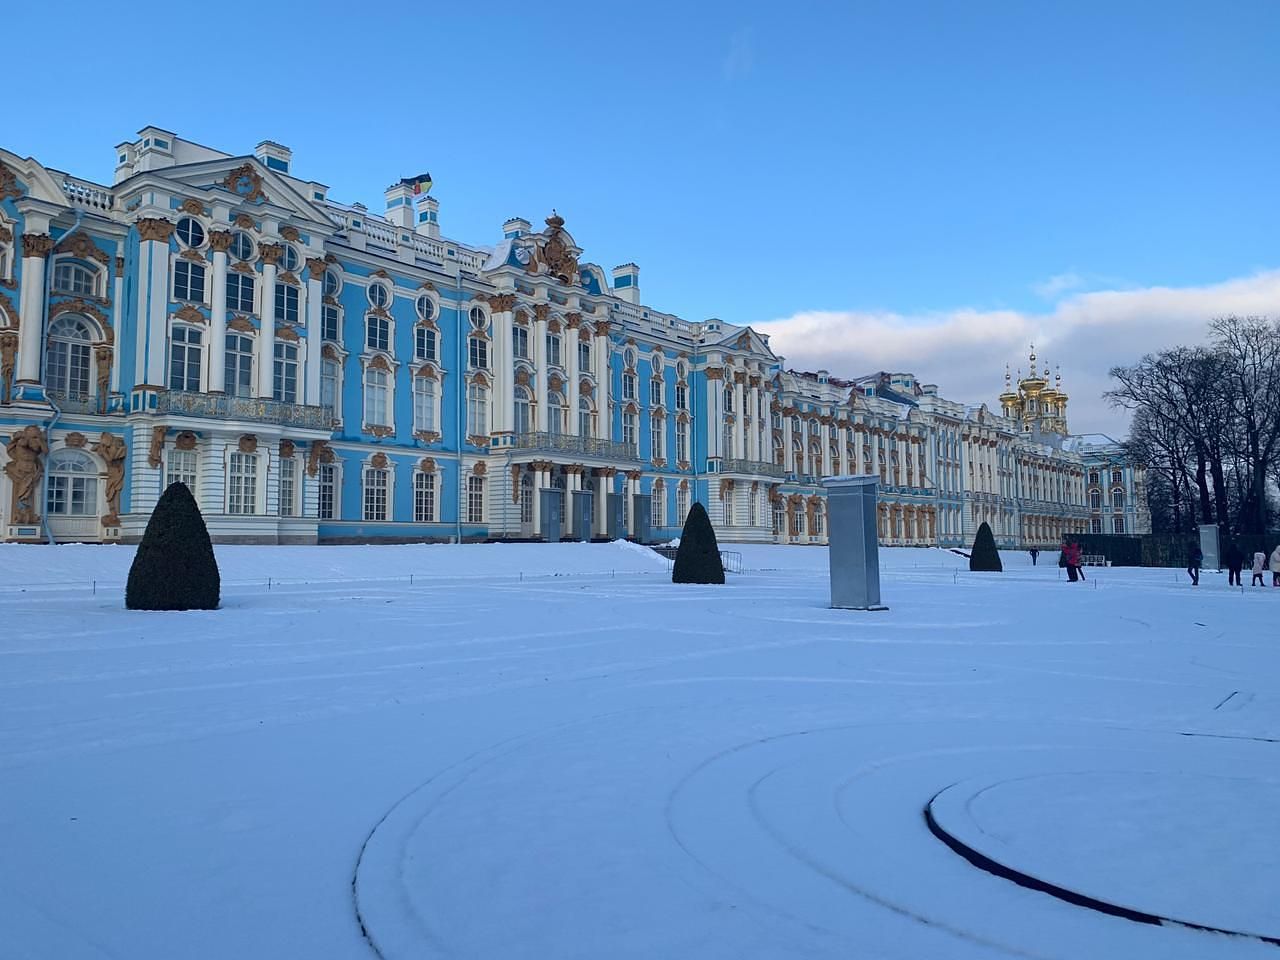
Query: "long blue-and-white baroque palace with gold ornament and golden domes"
0 127 1147 547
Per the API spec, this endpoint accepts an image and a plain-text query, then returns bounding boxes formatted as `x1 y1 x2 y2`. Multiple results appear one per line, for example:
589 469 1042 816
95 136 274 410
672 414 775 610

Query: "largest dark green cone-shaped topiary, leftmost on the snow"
124 484 221 611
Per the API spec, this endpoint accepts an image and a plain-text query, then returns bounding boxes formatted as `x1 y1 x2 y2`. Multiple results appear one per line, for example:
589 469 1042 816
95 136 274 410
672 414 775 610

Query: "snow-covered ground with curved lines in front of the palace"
0 544 1280 960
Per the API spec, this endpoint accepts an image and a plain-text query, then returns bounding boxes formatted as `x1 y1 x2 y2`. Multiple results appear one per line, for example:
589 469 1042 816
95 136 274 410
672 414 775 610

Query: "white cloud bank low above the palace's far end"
758 270 1280 435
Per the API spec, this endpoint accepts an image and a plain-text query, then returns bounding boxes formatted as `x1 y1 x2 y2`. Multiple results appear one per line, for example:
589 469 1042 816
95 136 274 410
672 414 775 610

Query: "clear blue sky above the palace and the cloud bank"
10 0 1280 427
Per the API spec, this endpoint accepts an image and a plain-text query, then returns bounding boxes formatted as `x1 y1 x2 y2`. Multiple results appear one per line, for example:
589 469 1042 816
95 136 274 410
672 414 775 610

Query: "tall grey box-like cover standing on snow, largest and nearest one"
822 476 888 611
